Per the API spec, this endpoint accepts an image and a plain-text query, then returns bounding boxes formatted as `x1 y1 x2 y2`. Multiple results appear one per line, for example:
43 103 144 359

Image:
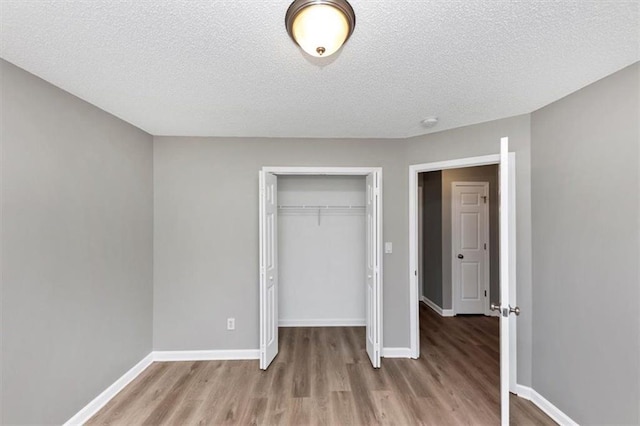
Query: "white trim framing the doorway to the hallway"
408 152 517 392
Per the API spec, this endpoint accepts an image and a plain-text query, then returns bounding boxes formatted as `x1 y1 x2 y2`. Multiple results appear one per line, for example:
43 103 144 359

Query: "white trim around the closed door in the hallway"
452 181 491 316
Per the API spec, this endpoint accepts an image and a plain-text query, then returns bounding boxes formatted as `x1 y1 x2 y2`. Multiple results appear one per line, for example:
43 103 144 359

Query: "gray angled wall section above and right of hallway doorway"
407 114 532 386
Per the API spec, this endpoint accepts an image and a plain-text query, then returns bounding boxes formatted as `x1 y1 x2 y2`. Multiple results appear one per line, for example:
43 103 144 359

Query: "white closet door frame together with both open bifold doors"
259 167 382 370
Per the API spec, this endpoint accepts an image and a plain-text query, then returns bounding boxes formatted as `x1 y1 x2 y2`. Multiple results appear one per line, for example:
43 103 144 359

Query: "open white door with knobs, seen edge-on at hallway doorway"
498 137 520 425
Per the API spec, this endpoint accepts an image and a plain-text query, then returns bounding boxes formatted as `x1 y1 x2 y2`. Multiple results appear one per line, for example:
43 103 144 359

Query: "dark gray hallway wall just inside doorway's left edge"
420 171 442 307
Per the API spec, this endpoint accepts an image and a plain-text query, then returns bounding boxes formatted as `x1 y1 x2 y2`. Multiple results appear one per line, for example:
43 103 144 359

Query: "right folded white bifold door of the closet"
366 172 382 368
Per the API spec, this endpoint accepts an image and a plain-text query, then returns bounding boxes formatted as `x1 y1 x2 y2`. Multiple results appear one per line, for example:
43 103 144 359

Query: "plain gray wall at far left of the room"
0 60 153 424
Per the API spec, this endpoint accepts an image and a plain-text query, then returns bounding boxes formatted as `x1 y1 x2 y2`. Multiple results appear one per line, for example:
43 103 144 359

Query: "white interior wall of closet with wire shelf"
278 176 366 326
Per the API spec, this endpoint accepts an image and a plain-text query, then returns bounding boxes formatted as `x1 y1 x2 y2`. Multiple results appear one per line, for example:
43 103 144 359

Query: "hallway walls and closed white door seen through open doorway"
417 164 500 316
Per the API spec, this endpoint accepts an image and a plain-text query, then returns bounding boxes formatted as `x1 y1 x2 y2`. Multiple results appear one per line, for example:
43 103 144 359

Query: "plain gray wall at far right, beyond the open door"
531 63 640 424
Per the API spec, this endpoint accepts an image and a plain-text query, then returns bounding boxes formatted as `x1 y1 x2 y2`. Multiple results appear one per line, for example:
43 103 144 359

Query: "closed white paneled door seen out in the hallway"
451 182 489 314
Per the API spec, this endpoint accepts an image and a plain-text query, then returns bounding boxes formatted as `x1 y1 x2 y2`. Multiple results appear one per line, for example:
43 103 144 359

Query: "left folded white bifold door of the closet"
260 171 278 370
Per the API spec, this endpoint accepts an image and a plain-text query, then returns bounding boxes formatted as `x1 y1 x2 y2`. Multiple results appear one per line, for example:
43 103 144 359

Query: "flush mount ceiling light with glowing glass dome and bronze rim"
284 0 356 57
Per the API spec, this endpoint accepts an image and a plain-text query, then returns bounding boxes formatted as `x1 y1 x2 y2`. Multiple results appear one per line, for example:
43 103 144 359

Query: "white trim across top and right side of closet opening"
260 166 384 364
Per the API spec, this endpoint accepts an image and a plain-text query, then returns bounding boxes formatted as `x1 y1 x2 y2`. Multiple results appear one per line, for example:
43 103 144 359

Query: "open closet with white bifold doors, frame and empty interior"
259 167 382 369
